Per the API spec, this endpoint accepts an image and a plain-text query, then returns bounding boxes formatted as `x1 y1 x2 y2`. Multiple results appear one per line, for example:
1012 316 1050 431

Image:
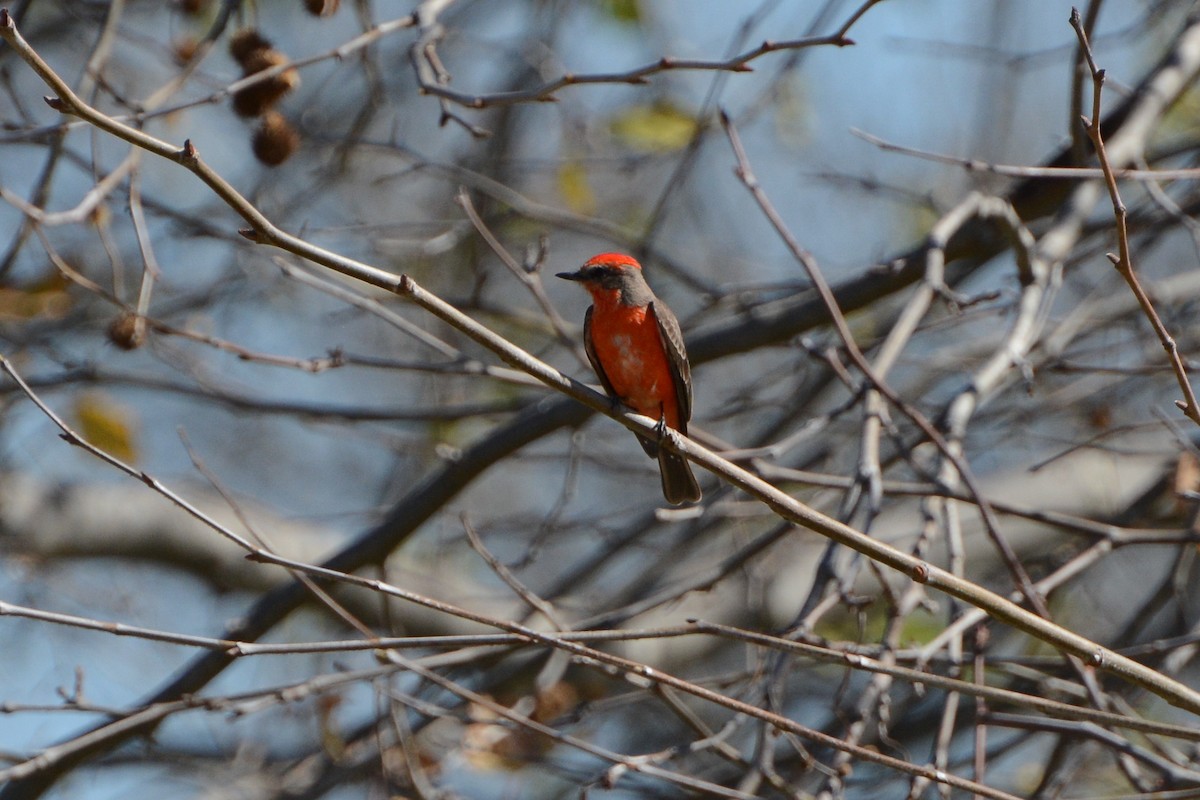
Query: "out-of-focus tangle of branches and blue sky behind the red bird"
0 0 1200 799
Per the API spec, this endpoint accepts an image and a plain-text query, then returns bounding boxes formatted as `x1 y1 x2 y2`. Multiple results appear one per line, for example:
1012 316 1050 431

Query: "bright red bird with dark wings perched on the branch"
558 253 700 505
